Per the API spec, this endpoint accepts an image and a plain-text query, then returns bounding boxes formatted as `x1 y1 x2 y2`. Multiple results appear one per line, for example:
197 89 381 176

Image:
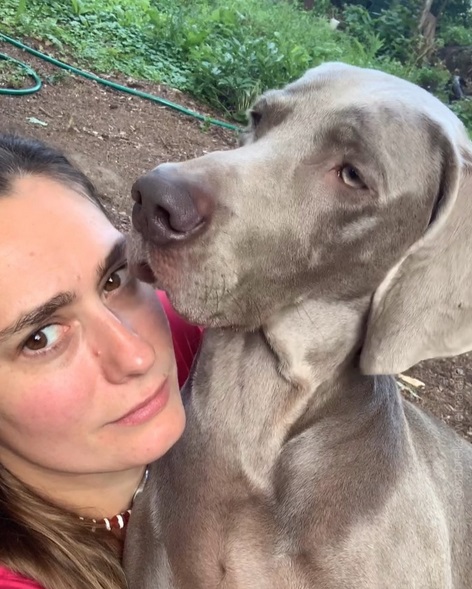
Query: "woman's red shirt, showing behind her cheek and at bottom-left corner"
0 292 202 589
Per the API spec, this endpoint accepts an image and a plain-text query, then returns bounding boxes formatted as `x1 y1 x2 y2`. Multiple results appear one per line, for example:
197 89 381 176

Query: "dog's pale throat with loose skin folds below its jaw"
189 300 382 488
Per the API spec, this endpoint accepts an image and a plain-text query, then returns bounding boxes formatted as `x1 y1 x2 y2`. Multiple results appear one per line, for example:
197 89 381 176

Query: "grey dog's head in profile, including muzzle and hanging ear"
132 64 472 373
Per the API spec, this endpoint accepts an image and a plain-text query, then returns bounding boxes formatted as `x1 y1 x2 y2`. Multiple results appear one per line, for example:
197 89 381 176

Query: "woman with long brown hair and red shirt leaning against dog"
0 135 199 589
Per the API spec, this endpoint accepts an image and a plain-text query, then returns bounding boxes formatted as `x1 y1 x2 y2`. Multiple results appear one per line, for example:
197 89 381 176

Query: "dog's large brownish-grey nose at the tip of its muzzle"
131 164 212 245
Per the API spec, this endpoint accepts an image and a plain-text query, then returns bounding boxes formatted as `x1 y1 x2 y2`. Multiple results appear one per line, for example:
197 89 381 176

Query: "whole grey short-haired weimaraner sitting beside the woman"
124 63 472 589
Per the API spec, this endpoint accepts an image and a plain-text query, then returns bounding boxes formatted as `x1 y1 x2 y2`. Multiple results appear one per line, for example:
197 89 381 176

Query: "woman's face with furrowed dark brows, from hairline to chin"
0 176 185 474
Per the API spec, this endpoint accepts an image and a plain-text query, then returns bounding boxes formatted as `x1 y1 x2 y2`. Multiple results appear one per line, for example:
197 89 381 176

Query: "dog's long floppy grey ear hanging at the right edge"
361 130 472 374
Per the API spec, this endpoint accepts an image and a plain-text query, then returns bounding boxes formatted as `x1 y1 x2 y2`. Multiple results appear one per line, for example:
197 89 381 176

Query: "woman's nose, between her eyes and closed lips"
91 309 155 384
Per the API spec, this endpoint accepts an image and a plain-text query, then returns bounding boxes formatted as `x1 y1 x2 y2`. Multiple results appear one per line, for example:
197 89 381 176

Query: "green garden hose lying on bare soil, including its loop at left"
0 33 240 131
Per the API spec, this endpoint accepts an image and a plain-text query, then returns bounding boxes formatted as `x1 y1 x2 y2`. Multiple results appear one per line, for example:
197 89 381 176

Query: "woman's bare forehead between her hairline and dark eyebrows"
0 177 120 315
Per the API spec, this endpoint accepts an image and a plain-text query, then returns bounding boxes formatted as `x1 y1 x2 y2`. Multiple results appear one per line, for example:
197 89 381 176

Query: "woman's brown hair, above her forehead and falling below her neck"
0 134 126 589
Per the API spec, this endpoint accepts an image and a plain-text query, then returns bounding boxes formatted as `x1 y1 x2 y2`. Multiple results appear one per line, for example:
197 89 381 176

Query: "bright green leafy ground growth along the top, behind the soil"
0 0 472 129
